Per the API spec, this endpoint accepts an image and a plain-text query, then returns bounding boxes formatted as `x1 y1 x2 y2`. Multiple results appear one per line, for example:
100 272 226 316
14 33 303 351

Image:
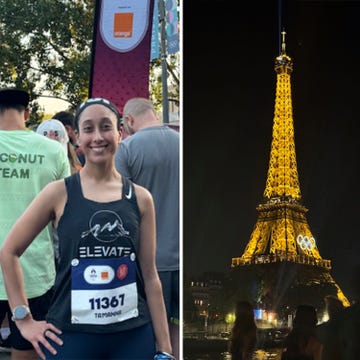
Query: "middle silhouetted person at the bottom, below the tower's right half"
281 304 323 360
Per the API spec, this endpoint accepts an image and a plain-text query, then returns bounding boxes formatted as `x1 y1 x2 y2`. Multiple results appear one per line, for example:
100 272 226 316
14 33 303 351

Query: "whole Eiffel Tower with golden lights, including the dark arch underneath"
231 31 350 311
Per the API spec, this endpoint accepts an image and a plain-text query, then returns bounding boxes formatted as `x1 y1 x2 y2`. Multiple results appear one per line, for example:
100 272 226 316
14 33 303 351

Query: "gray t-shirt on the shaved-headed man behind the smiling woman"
115 125 180 271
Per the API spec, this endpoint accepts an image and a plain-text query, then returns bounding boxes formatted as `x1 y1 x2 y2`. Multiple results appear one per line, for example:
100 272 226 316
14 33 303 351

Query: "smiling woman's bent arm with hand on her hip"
0 180 66 358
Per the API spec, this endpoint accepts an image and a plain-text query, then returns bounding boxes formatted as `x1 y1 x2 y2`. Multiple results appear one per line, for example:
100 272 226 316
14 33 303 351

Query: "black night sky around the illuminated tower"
182 0 360 299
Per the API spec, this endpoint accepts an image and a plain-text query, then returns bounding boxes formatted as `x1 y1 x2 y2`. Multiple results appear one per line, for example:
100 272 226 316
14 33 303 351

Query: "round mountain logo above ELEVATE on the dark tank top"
81 210 129 242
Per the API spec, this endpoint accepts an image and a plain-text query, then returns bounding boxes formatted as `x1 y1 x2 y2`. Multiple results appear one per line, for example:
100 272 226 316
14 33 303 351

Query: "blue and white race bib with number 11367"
71 254 139 325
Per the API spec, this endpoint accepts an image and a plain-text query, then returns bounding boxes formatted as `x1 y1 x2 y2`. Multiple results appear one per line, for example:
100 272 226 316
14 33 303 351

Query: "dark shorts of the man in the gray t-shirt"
159 270 180 325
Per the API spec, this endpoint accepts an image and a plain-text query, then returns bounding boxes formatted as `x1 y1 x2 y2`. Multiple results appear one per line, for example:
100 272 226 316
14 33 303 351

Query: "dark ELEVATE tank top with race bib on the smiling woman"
47 173 150 333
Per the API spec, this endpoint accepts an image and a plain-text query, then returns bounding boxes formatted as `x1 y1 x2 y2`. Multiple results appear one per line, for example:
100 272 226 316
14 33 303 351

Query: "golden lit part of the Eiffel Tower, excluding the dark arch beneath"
231 31 349 305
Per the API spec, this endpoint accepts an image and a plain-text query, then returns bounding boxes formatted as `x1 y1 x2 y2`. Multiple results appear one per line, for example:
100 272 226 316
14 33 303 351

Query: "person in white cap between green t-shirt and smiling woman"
36 119 82 174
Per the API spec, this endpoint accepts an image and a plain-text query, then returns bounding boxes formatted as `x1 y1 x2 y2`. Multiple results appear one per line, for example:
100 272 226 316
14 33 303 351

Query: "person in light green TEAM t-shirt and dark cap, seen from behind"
0 88 70 360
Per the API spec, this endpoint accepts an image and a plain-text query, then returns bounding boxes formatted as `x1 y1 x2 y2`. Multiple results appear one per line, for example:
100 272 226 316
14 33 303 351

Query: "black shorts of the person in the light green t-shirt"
0 289 53 350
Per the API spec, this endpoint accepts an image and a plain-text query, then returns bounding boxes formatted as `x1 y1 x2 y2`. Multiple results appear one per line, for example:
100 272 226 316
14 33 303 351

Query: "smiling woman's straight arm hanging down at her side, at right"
135 185 172 354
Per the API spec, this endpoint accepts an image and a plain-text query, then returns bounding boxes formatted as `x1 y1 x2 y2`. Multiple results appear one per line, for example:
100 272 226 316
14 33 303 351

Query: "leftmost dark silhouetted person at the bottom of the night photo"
229 300 257 360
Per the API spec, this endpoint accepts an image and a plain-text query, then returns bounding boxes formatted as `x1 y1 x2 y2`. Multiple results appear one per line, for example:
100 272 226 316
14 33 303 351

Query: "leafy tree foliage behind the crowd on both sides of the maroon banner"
0 0 179 124
